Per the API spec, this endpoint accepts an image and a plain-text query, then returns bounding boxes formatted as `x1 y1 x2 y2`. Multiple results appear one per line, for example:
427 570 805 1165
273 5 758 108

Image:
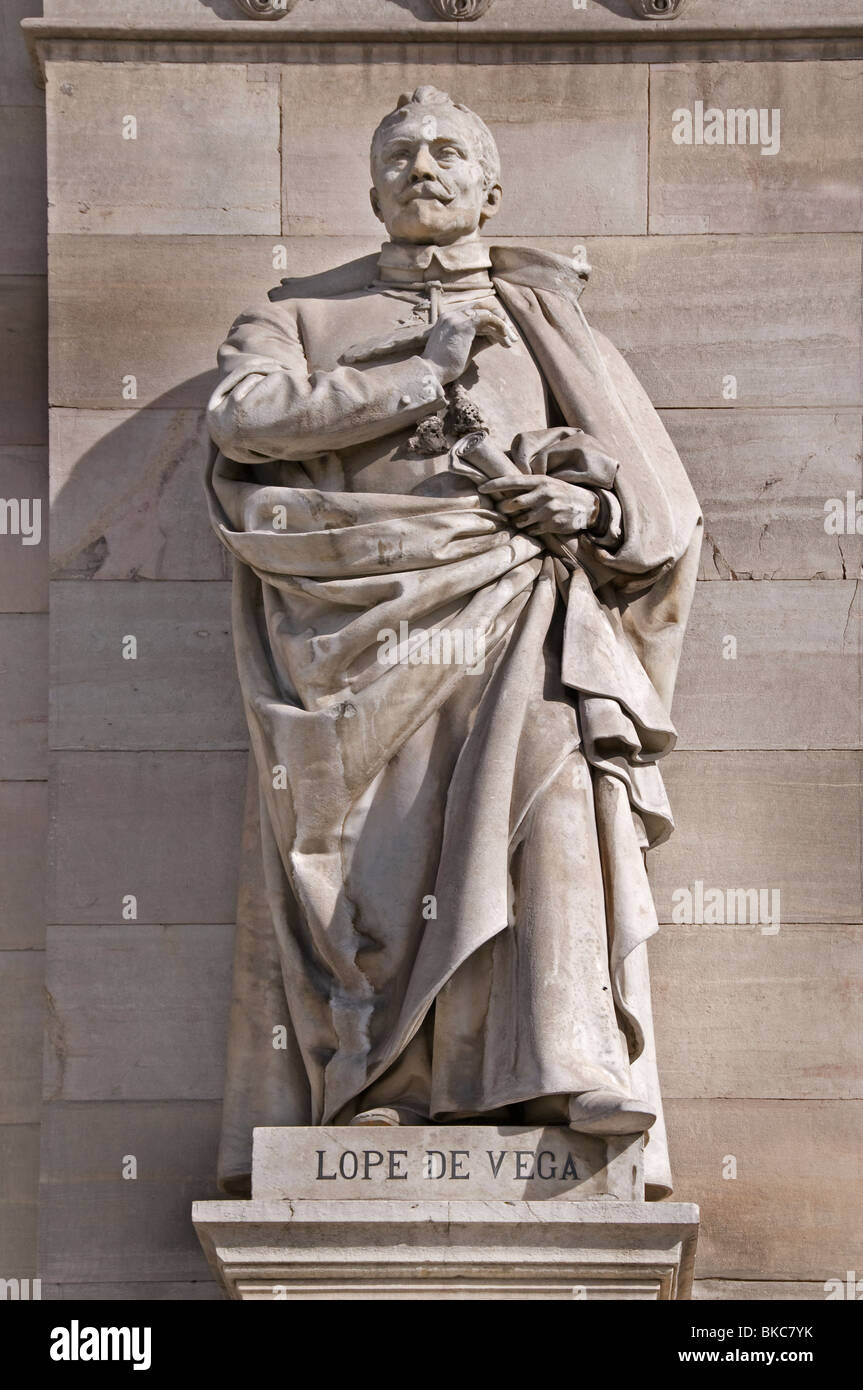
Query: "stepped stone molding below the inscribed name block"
193 1198 698 1301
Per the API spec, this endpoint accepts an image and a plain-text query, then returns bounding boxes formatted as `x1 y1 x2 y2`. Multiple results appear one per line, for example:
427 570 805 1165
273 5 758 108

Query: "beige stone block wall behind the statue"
0 0 863 1298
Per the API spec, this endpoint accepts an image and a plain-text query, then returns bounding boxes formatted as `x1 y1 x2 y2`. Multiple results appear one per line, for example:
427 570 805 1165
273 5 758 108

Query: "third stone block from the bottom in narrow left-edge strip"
0 781 49 951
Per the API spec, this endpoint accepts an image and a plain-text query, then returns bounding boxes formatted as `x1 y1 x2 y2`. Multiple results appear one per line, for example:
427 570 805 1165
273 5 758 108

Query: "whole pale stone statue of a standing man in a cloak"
208 86 700 1195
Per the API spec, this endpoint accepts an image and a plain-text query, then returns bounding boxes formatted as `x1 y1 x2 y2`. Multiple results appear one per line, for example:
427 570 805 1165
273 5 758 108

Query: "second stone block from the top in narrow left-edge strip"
0 106 47 275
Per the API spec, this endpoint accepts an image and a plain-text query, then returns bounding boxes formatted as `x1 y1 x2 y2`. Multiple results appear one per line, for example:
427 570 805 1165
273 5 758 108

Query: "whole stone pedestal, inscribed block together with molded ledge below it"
192 1126 698 1300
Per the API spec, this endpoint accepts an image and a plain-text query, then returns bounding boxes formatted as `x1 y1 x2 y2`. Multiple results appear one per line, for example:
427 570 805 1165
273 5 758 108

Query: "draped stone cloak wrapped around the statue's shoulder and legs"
207 247 700 1197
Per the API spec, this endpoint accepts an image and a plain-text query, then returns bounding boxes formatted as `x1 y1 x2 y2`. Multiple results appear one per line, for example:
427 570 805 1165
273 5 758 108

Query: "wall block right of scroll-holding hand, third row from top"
663 406 863 580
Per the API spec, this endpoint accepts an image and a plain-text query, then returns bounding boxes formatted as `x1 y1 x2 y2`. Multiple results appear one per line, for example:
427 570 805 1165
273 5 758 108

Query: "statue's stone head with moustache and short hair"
371 86 500 246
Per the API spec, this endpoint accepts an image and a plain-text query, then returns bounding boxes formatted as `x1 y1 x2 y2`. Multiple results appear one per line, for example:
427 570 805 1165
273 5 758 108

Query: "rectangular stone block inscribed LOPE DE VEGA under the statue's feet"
252 1125 643 1205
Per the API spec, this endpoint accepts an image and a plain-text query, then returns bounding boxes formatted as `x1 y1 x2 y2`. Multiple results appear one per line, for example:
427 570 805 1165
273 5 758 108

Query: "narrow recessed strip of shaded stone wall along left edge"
0 0 49 1301
